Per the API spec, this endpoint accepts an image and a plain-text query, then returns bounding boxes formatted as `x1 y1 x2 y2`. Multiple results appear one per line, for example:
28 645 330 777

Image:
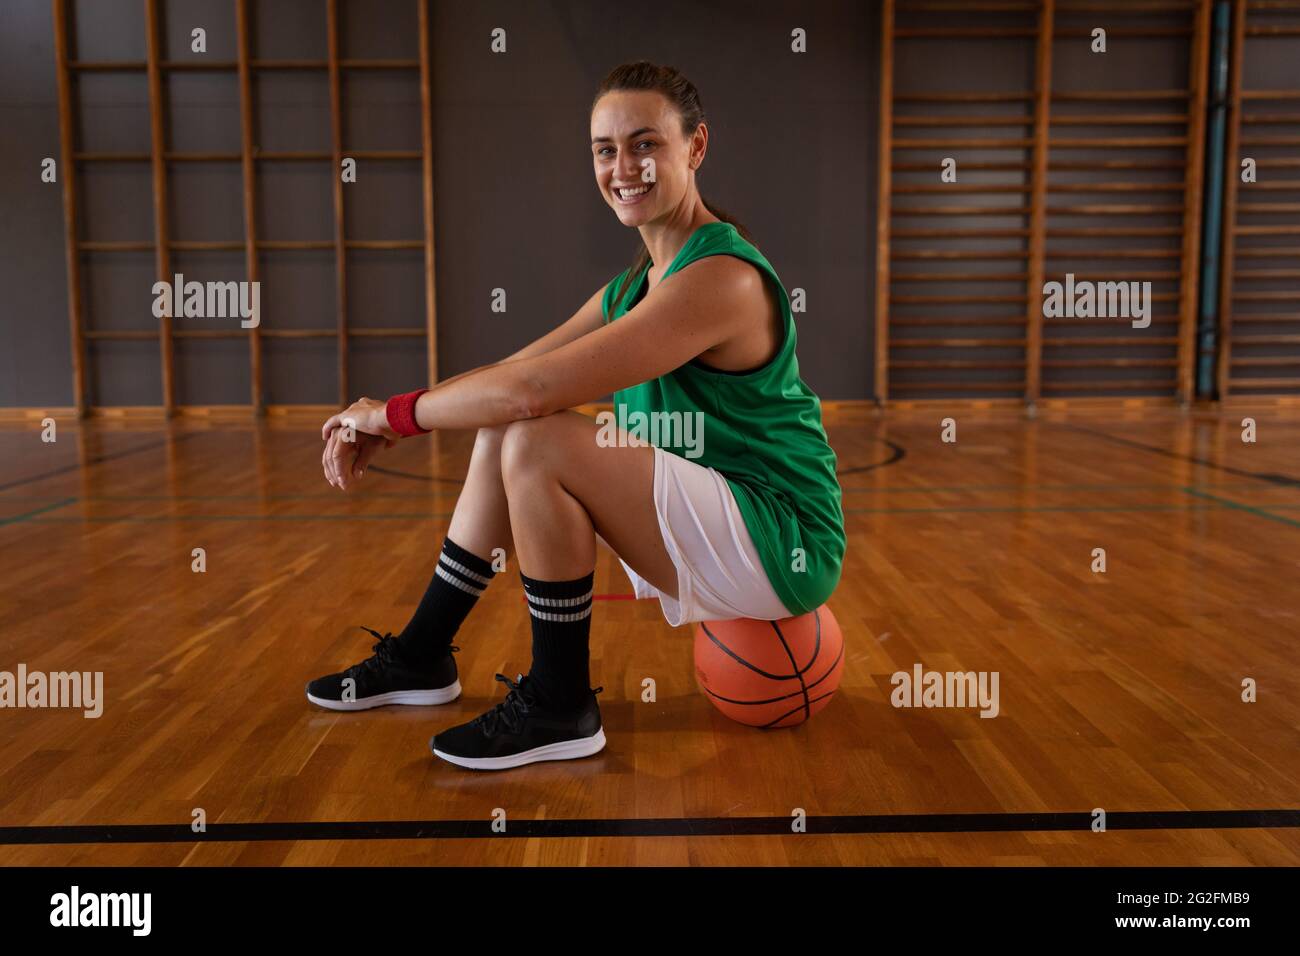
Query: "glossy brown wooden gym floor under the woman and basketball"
0 407 1300 865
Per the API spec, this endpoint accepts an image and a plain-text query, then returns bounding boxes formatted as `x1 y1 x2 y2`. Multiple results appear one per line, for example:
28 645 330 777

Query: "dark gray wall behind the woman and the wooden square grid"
0 0 879 406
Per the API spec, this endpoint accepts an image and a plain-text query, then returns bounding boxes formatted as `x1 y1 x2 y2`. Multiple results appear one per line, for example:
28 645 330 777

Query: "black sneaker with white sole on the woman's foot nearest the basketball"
429 674 605 770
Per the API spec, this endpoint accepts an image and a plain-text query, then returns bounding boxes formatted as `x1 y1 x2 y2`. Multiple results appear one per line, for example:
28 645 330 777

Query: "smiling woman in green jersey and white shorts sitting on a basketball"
307 62 845 770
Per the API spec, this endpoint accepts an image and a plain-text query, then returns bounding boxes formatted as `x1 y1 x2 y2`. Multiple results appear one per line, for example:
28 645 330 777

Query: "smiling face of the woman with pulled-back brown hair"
592 90 709 226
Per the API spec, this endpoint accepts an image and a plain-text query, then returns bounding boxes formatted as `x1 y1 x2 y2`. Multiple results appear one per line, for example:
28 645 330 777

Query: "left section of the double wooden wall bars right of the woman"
876 0 1034 405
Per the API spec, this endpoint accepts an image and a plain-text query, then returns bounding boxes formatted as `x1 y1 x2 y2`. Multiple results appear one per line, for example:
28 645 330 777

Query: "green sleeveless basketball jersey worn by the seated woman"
602 222 845 614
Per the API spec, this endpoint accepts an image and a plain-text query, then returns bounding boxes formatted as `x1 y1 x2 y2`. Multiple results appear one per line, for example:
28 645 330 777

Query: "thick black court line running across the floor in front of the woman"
0 810 1300 845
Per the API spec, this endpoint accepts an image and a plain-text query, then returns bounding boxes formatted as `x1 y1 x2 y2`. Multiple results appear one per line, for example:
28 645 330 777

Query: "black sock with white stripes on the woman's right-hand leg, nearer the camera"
519 571 595 711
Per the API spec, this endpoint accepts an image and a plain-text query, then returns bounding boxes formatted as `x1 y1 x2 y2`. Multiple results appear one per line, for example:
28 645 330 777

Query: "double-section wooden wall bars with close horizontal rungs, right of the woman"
876 0 1210 403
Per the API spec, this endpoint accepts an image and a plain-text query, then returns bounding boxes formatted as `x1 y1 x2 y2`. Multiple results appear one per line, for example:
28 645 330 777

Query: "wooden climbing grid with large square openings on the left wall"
51 0 438 415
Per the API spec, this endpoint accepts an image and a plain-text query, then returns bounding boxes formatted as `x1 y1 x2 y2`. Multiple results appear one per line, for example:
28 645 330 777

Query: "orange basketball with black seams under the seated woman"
696 605 844 728
